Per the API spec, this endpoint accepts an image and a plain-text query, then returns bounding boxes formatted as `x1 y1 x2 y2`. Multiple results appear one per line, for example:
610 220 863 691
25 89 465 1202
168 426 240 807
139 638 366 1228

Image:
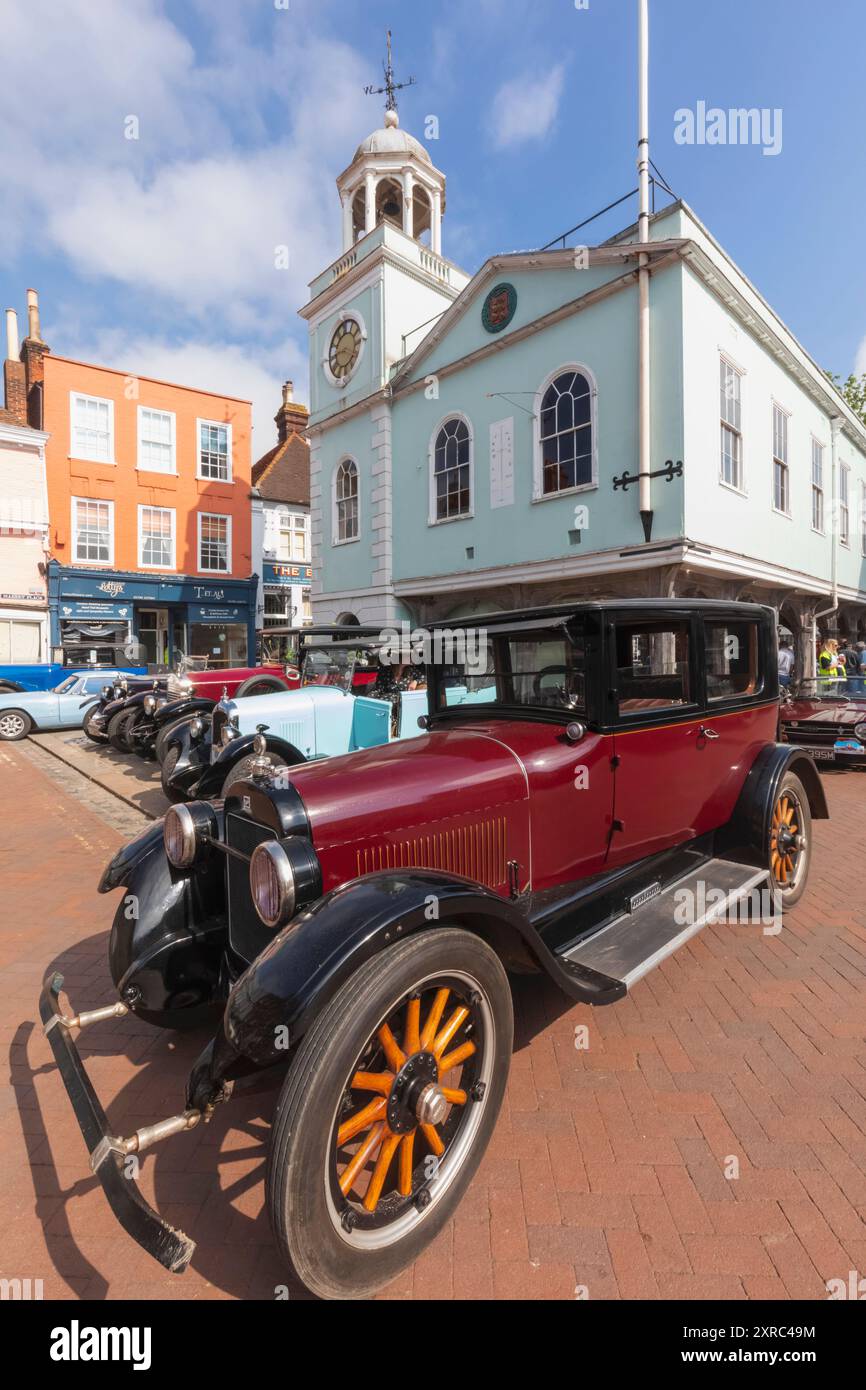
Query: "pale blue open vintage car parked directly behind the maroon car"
163 635 427 802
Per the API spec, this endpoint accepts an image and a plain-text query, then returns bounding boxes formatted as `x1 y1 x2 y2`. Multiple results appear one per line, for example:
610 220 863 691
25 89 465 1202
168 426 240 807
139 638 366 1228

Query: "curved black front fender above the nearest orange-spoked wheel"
188 869 624 1105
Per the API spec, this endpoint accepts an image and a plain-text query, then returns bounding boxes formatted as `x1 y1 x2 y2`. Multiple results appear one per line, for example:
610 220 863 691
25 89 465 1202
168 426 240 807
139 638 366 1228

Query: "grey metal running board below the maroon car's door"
562 859 767 988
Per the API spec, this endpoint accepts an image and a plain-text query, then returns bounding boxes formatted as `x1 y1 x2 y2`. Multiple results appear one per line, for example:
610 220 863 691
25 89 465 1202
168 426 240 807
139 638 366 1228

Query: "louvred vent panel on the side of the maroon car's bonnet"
357 816 509 888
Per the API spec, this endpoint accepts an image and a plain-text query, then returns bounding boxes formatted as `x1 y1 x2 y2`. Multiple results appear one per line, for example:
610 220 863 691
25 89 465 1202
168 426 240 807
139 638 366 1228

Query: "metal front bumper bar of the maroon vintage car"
39 974 196 1275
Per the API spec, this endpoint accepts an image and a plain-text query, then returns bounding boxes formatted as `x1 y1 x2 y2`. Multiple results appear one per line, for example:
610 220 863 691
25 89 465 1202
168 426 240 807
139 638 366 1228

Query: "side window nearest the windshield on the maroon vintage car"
616 621 695 714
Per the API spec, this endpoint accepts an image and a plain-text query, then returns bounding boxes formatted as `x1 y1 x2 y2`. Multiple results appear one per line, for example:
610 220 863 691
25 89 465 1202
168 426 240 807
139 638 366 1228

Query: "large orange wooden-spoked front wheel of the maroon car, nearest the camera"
268 927 512 1298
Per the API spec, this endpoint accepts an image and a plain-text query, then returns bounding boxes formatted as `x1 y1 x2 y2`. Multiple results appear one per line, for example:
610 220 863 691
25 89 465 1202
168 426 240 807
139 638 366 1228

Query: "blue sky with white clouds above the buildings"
0 0 866 457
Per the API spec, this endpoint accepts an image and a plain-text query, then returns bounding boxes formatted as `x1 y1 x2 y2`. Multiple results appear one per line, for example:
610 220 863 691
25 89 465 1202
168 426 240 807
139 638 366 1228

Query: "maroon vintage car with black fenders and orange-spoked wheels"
40 600 827 1298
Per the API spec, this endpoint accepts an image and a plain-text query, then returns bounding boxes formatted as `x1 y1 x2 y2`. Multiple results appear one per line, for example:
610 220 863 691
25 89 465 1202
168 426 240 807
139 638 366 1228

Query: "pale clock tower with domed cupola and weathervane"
300 35 470 621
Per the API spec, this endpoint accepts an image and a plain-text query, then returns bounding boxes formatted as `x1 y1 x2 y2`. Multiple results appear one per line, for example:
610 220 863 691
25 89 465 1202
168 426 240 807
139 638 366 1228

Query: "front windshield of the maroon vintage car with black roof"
435 631 587 714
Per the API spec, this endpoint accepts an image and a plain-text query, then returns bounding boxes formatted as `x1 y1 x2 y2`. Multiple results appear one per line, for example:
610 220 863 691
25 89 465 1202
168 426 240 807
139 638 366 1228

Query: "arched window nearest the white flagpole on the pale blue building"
535 367 595 496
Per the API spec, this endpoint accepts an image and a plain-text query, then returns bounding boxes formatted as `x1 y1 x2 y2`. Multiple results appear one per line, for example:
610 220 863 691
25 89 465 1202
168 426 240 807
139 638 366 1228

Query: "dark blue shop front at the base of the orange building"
49 560 259 667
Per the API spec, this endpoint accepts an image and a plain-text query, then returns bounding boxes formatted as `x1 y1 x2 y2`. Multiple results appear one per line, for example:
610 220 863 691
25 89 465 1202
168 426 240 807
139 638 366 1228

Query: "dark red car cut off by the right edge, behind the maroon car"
780 677 866 767
